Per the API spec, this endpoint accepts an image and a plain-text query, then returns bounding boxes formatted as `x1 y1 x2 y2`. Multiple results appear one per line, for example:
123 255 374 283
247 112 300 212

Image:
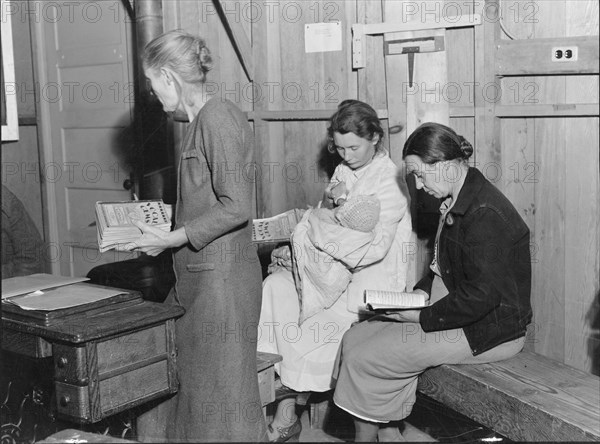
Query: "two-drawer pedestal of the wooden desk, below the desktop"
53 319 178 423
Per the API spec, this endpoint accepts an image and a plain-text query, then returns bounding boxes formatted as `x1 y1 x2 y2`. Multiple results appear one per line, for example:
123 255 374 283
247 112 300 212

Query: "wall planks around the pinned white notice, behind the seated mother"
252 0 357 216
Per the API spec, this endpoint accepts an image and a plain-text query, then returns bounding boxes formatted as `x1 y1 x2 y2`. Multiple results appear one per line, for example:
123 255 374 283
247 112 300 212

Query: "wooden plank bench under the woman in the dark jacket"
418 352 600 442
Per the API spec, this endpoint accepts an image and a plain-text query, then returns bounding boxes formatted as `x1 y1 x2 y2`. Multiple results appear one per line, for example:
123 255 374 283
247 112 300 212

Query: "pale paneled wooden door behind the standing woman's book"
29 0 134 276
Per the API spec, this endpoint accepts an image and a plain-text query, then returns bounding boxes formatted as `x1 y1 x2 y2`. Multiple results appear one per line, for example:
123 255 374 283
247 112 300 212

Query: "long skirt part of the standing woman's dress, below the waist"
138 248 267 442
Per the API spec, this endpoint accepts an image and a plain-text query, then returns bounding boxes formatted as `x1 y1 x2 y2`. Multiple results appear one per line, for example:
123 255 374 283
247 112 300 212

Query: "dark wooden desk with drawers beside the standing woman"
2 290 184 423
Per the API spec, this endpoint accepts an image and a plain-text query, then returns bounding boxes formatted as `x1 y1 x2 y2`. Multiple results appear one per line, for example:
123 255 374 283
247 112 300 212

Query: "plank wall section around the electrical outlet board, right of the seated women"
490 0 600 374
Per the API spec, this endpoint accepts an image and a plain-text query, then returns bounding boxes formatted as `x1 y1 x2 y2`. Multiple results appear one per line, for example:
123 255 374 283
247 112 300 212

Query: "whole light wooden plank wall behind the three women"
163 0 600 373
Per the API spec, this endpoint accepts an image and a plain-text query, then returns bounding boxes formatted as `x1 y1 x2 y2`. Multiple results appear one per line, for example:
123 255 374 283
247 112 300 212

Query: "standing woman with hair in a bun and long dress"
128 31 267 442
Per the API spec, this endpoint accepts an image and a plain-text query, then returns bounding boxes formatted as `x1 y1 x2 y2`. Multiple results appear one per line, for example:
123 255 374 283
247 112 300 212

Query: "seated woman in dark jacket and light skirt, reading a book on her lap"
334 123 532 441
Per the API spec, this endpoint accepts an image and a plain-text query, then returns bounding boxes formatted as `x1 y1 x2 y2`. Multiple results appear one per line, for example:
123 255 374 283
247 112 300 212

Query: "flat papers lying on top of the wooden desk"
3 284 123 311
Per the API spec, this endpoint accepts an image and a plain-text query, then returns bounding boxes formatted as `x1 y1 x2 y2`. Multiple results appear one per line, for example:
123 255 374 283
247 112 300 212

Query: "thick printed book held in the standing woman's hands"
96 199 171 252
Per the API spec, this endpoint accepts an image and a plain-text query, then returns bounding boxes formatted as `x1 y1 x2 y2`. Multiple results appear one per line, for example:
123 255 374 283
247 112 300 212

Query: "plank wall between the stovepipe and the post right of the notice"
163 0 356 217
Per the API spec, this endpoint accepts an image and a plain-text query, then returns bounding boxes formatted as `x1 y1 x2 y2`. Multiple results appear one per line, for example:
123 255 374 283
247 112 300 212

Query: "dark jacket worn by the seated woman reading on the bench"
416 168 532 355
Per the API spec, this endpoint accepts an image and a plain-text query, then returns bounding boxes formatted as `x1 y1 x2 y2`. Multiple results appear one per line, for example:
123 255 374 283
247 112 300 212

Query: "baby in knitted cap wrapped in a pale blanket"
292 195 380 324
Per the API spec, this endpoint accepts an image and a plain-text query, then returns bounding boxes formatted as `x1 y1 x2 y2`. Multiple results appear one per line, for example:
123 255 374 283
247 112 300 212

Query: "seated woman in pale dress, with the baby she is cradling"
258 100 412 442
